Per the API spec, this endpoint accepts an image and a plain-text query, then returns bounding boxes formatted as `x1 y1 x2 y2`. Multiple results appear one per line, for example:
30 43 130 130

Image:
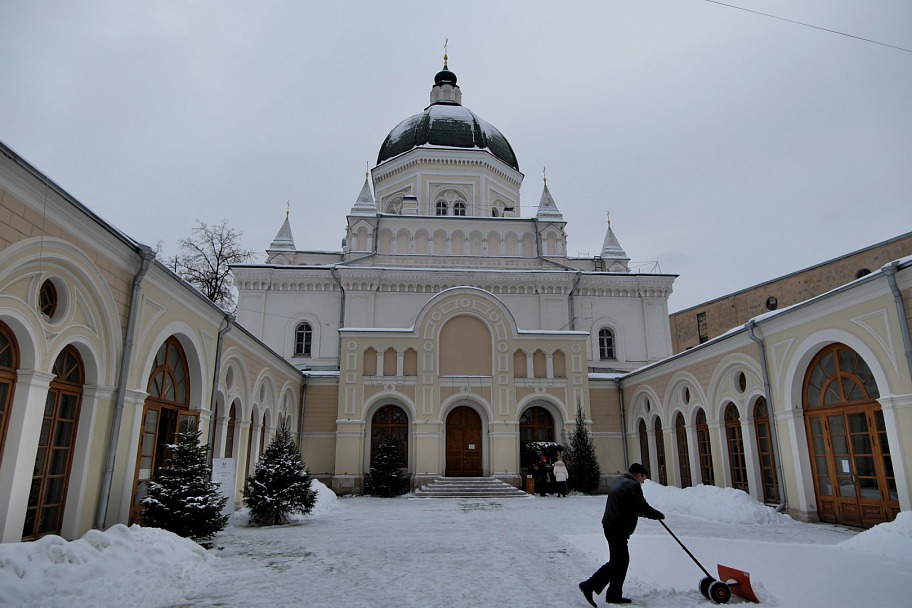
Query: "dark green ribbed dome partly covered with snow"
377 104 519 171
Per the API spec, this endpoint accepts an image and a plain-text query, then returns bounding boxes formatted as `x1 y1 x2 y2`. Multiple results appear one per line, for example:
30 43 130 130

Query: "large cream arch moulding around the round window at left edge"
0 236 122 385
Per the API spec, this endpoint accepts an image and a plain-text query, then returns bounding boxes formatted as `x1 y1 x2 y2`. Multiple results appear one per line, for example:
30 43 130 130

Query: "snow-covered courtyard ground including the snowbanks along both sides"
0 481 912 608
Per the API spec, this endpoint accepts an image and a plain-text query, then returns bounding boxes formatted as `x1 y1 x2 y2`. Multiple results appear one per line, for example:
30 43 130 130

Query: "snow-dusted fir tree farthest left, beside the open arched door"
141 430 228 542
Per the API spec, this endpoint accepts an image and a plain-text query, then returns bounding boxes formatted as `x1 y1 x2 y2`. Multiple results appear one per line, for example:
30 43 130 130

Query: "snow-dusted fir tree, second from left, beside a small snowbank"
244 421 317 526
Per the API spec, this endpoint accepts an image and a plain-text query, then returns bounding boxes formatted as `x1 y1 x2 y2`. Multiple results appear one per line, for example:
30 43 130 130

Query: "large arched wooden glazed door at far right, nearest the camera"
802 343 899 528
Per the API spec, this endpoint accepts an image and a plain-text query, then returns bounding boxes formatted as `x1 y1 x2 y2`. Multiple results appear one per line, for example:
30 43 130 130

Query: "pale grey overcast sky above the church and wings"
0 0 912 311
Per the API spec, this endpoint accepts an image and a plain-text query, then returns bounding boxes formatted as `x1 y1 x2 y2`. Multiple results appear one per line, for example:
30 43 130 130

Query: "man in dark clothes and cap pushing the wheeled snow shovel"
579 462 665 606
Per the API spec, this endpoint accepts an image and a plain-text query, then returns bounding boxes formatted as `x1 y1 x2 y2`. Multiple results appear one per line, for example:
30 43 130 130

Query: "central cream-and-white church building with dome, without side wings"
233 59 674 493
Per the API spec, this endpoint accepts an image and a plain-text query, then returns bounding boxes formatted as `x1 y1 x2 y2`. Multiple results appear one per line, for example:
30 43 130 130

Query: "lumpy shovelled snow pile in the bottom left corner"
0 524 217 608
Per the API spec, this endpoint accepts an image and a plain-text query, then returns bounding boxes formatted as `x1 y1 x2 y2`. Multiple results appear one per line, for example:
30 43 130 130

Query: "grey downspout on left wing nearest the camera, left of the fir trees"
95 245 155 530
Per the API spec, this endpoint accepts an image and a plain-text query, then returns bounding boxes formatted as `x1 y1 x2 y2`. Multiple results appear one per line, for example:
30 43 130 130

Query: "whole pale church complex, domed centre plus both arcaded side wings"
0 57 912 542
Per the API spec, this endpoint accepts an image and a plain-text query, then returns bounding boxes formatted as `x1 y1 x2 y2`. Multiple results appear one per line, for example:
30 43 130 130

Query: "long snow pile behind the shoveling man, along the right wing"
643 479 795 524
